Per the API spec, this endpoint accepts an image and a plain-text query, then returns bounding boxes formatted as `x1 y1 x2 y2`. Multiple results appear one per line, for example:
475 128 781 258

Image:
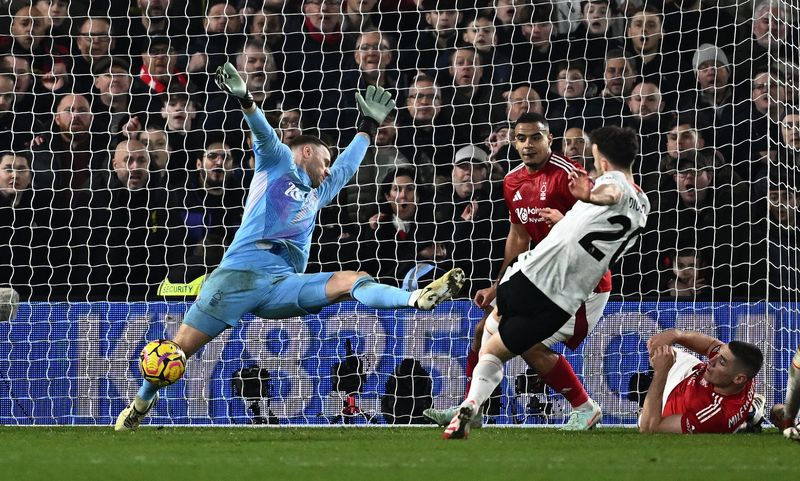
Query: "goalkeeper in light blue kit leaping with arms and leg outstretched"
115 63 464 431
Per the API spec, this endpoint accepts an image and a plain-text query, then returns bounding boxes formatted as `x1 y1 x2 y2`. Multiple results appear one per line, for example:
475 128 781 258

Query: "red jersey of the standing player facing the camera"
503 153 611 292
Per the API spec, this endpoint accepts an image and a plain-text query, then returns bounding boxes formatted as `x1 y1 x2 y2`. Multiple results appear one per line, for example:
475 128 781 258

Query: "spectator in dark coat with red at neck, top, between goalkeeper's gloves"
280 0 353 137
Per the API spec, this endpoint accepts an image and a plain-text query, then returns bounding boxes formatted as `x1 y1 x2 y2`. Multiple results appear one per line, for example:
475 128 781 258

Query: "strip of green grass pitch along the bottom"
0 426 800 481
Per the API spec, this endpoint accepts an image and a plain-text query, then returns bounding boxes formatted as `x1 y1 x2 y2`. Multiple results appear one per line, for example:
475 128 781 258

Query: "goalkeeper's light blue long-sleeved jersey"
220 108 369 274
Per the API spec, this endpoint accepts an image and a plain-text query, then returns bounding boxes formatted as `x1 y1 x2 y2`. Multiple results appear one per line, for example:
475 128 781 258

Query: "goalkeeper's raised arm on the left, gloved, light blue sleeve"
214 62 289 169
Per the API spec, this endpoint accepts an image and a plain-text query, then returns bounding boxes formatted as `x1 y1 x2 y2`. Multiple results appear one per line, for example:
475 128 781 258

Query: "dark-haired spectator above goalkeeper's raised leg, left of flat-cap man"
359 167 440 286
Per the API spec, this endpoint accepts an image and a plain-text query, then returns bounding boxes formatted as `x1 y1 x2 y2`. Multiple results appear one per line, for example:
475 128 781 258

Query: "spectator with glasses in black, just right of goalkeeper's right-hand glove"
397 74 456 184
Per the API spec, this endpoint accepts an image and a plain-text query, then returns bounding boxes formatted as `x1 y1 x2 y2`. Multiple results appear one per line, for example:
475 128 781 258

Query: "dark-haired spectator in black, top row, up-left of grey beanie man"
626 6 680 110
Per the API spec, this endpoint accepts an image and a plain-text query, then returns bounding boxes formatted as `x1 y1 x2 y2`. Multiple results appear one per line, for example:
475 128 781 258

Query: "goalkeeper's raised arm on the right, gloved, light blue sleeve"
319 85 395 205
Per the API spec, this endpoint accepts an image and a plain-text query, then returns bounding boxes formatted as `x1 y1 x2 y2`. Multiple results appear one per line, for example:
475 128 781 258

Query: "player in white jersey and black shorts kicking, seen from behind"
442 126 650 439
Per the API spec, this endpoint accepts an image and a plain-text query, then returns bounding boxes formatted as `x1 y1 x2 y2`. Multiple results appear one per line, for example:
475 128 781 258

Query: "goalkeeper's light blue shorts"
183 268 333 337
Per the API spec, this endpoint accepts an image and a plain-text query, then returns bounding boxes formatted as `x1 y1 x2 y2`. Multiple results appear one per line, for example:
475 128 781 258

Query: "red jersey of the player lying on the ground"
662 346 755 433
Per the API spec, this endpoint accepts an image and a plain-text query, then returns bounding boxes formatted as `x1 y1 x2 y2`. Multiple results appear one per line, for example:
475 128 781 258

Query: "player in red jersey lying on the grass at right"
639 329 764 433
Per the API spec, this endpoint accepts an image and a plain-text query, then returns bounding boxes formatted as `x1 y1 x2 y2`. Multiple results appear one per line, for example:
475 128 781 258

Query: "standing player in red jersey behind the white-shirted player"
424 113 611 431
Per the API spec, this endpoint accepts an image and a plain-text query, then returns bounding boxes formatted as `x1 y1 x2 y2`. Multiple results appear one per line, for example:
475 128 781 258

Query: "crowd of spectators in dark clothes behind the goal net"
0 0 800 300
